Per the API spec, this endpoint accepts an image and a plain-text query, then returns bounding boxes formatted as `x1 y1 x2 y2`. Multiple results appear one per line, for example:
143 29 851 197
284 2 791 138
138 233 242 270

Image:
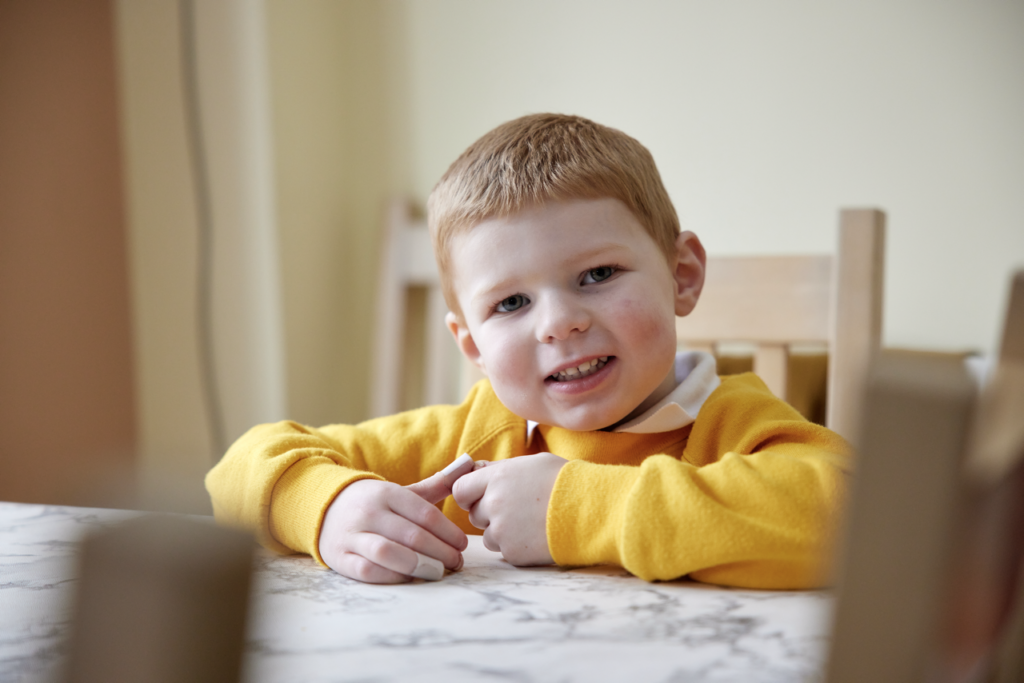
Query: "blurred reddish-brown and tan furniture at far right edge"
958 270 1024 683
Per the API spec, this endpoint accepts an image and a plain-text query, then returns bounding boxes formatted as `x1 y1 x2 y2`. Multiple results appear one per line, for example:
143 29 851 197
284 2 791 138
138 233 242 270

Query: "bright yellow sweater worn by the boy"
206 374 850 589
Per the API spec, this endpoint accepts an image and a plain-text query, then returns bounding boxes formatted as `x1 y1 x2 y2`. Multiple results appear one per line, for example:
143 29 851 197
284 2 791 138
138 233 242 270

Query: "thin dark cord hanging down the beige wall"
178 0 226 462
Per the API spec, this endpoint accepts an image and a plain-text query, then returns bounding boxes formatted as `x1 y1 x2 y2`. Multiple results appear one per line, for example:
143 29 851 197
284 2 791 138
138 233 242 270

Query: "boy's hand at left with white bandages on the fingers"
318 461 472 584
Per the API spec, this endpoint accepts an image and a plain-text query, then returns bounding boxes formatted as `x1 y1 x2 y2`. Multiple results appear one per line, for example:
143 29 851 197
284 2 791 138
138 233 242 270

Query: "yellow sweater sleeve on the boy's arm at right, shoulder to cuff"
548 375 851 589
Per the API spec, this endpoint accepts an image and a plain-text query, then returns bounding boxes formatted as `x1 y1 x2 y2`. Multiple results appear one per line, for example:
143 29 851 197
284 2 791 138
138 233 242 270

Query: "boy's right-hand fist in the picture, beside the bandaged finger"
452 453 568 566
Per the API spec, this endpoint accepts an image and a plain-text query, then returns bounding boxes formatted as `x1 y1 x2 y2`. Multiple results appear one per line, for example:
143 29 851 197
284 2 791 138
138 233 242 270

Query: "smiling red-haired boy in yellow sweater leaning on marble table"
207 115 849 589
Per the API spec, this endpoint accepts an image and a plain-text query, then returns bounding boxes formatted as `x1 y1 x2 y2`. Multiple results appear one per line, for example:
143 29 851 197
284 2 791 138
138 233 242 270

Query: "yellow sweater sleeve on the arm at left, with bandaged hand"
206 394 485 564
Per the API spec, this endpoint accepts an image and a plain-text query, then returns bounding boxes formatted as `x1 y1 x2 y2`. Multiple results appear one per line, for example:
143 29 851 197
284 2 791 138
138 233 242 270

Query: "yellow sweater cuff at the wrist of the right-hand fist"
547 460 640 566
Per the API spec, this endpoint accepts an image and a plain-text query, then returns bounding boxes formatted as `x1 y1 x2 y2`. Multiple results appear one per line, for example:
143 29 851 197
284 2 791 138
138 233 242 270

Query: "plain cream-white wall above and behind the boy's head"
395 0 1024 358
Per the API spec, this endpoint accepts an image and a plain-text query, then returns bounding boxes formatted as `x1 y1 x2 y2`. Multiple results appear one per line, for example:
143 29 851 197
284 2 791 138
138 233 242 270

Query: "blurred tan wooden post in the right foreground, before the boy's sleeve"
825 353 974 683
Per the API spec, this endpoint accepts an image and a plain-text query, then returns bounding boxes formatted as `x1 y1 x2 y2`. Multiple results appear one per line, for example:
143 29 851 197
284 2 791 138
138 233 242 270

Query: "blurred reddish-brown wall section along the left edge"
0 0 136 505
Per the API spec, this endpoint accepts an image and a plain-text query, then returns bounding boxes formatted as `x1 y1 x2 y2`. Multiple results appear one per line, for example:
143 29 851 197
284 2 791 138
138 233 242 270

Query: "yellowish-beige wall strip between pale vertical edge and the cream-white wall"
267 0 408 424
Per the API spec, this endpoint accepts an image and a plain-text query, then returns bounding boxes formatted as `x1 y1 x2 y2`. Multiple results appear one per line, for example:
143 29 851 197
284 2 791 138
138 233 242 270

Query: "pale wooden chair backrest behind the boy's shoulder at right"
676 209 886 444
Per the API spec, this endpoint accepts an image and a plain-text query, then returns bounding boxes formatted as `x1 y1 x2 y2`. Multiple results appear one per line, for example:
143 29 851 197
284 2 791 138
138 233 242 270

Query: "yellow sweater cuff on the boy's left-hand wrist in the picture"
269 458 383 566
